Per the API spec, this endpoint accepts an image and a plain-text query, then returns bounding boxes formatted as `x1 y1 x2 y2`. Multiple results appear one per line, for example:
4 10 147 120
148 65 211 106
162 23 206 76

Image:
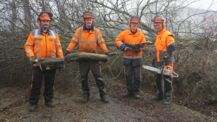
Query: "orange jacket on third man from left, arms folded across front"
115 29 146 59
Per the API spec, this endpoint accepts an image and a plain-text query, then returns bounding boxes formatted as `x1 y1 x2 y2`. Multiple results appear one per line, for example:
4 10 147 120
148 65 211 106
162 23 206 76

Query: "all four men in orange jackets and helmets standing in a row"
24 11 175 112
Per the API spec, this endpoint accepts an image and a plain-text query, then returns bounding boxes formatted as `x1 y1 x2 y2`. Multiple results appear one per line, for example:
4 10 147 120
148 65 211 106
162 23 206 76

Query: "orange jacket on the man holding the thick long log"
66 27 108 53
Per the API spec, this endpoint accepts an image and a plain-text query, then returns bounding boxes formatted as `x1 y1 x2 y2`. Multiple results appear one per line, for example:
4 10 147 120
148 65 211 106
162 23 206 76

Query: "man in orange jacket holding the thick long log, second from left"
66 12 108 103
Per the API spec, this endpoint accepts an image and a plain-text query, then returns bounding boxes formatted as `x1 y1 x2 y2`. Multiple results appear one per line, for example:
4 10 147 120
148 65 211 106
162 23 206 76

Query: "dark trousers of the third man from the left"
124 59 142 94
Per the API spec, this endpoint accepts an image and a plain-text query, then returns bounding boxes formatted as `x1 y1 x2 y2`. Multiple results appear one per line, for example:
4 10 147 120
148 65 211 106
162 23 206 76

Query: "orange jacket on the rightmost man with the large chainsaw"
155 28 175 62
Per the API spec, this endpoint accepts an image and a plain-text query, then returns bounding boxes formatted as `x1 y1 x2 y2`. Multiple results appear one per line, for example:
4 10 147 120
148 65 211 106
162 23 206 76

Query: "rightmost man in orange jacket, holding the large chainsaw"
152 15 175 105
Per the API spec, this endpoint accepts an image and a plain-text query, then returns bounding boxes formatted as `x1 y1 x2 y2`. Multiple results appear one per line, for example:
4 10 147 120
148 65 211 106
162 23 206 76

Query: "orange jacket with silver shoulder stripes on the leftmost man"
24 29 64 58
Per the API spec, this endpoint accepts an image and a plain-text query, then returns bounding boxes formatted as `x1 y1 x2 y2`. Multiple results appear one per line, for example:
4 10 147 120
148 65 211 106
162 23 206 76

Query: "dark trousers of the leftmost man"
29 67 56 105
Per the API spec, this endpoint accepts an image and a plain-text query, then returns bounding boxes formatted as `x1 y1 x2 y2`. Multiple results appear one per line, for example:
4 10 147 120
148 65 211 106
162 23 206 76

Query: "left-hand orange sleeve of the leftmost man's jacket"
24 33 35 58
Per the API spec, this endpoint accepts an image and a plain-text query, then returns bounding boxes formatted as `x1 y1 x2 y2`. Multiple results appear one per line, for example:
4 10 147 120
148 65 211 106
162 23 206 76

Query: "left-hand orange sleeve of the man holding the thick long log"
66 28 81 52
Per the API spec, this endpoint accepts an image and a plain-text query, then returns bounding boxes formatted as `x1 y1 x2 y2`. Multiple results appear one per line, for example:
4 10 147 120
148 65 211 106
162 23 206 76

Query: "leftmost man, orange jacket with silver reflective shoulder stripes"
24 11 64 112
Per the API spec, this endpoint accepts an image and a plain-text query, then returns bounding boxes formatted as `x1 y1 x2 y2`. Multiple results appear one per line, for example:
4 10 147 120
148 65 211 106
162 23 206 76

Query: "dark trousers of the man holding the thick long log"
79 61 105 97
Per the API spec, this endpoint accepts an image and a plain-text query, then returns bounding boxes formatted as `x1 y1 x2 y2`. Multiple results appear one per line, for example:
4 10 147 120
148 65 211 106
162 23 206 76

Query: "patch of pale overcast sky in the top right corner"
190 0 217 11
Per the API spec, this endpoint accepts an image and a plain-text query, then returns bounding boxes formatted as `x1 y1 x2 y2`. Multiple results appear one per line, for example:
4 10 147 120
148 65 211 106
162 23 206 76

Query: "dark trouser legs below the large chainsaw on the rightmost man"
156 74 172 98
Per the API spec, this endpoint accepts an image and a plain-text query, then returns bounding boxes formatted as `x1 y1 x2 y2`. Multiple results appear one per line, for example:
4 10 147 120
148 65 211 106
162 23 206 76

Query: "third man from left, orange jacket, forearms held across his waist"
115 17 146 98
